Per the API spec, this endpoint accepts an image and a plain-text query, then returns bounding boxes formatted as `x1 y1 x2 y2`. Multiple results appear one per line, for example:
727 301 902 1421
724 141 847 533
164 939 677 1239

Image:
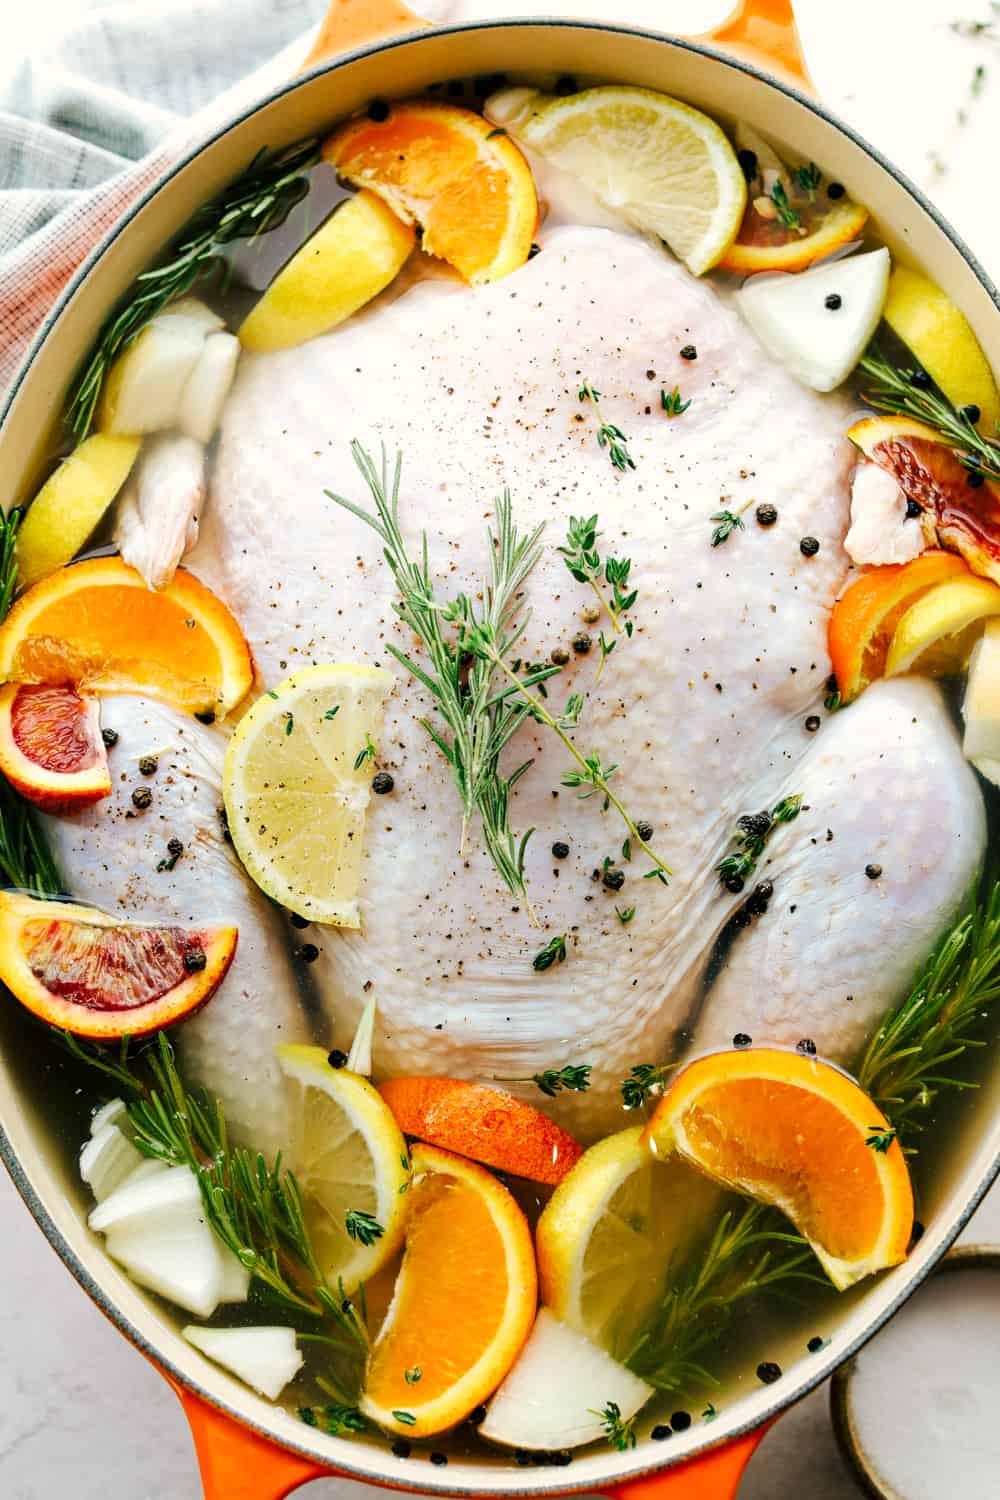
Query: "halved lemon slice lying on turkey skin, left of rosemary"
222 662 393 927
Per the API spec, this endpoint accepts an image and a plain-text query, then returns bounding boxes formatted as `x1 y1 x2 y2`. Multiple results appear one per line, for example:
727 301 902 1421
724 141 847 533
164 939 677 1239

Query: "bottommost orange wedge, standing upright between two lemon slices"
361 1145 538 1437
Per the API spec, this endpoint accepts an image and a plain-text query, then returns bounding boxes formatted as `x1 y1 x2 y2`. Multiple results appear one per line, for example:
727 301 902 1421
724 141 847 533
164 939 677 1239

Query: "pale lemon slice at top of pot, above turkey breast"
507 86 747 276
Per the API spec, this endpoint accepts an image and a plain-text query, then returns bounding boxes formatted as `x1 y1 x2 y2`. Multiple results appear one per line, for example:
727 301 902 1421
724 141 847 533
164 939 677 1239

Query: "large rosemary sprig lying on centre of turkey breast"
325 440 559 918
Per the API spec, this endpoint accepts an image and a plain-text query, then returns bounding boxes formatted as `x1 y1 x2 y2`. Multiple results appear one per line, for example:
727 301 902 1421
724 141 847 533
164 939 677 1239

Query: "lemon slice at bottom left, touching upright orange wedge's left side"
277 1046 409 1292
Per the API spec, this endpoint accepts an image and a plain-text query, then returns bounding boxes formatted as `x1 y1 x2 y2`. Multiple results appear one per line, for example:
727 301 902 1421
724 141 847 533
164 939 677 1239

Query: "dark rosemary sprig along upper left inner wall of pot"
66 141 319 443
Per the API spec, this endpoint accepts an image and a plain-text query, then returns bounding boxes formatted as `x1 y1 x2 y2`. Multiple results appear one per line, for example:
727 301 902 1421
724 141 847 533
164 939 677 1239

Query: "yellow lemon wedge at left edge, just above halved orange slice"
18 432 139 588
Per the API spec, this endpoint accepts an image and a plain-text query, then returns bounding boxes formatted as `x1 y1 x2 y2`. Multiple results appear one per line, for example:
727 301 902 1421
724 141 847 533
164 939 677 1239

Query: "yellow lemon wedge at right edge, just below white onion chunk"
882 266 1000 432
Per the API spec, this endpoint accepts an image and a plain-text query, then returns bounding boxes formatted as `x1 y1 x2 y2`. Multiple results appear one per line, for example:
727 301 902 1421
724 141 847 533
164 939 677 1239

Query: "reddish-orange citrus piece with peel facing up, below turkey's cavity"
379 1079 582 1184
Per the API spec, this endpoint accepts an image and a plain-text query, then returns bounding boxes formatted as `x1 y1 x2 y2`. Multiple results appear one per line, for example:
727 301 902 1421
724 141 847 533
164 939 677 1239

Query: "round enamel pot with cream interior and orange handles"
0 0 1000 1500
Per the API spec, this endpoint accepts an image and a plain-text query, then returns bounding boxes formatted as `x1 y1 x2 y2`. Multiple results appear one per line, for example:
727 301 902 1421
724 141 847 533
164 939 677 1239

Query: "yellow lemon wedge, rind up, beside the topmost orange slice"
240 191 417 353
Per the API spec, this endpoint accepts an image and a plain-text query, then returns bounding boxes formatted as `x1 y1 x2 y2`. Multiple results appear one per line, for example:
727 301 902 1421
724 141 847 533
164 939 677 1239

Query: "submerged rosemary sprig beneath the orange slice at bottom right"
625 1203 829 1391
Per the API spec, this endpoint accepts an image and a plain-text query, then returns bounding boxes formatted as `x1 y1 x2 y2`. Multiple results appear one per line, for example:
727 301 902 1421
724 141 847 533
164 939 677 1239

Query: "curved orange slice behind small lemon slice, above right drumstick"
826 552 970 704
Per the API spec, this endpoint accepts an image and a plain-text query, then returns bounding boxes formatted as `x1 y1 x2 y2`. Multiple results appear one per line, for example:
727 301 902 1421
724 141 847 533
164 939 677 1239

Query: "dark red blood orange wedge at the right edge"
847 417 1000 584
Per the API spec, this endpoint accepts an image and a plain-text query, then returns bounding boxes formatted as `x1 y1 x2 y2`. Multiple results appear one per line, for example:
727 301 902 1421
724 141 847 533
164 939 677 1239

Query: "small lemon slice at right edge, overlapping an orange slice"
886 578 1000 677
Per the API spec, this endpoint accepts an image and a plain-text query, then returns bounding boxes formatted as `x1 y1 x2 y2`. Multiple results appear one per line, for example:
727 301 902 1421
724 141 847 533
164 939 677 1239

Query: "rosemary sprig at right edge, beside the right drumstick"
858 882 1000 1149
